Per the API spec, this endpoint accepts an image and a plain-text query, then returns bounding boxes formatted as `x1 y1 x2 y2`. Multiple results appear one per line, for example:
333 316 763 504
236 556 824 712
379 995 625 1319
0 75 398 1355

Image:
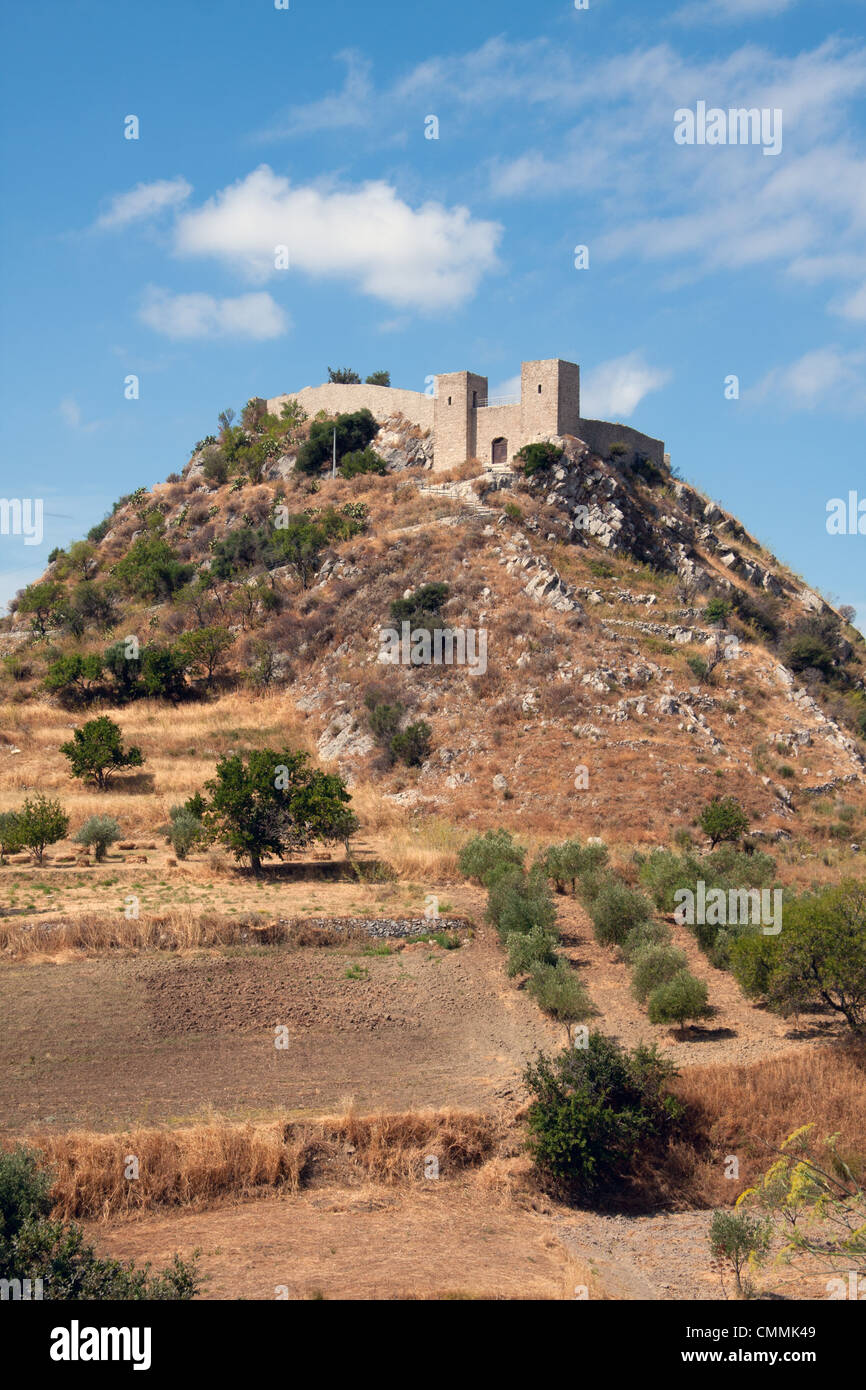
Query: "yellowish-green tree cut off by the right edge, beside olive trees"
731 878 866 1034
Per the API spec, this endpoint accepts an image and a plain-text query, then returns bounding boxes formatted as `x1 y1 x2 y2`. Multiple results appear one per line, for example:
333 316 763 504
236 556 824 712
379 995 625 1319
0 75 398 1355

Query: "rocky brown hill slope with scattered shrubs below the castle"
0 403 866 859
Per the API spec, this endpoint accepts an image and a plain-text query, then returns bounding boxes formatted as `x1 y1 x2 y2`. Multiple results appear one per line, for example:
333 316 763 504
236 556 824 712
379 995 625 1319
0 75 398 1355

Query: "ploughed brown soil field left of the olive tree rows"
0 933 563 1131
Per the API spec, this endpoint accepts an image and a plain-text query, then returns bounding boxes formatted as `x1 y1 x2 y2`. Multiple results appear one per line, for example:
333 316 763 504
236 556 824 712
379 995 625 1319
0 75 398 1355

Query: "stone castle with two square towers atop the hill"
267 357 664 473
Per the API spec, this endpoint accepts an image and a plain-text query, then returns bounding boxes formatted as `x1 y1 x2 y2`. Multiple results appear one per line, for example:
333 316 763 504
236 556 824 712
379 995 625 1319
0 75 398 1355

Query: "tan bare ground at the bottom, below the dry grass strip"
88 1182 578 1300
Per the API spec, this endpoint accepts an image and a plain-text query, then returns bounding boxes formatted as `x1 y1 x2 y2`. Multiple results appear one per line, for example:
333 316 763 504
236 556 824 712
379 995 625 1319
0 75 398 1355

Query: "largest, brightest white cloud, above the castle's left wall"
177 164 502 310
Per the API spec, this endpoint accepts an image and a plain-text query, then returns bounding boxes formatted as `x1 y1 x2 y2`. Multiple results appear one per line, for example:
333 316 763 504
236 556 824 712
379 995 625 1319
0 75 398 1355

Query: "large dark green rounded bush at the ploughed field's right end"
524 1031 683 1195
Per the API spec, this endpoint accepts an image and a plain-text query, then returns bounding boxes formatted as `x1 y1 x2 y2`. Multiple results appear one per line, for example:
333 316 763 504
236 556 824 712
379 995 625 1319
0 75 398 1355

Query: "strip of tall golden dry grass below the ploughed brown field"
22 1108 503 1220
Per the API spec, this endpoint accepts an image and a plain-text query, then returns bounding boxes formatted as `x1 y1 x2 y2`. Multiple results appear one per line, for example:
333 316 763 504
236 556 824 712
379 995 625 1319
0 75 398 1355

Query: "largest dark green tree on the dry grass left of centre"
202 748 357 874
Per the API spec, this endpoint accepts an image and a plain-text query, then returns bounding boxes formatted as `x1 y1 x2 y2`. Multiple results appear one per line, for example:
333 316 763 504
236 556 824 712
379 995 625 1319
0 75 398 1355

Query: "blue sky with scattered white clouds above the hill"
0 0 866 626
